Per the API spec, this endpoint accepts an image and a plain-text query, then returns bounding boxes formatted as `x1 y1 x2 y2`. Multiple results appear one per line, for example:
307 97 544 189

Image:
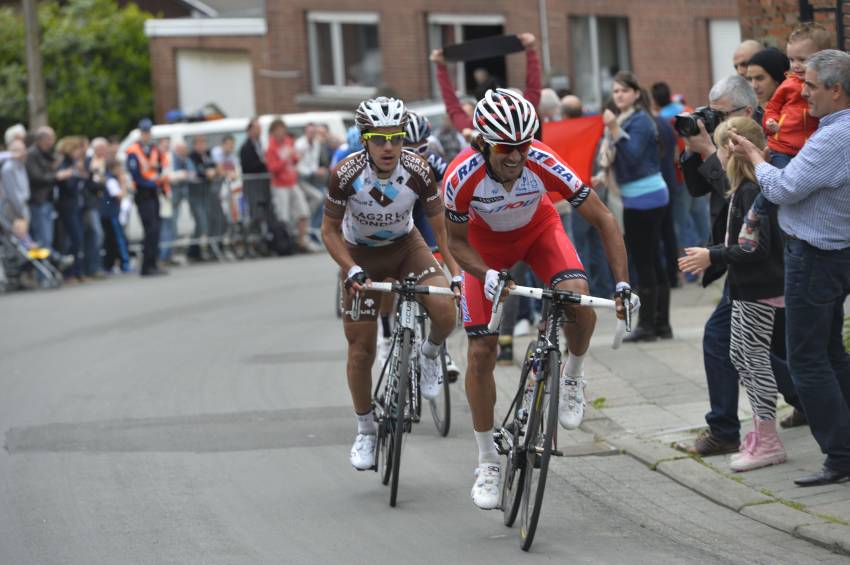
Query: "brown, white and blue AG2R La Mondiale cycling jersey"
325 150 443 247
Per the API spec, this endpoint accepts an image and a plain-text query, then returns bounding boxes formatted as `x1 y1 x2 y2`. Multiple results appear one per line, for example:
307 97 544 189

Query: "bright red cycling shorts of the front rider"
461 210 587 337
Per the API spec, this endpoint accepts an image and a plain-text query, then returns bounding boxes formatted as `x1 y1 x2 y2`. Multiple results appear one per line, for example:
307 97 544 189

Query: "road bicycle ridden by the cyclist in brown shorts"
351 277 454 506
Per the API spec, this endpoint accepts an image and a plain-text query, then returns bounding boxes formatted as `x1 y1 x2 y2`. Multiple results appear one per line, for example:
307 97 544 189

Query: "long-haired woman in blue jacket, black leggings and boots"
602 71 673 341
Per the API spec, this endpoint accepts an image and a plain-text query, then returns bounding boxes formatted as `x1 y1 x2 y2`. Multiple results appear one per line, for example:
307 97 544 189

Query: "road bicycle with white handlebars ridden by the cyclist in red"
488 274 633 551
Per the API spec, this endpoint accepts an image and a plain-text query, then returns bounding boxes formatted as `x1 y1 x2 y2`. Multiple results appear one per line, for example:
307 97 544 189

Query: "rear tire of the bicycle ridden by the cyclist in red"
502 341 537 528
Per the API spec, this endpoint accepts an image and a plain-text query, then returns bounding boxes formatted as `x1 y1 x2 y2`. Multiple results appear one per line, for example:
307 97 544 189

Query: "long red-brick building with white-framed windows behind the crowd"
146 0 741 120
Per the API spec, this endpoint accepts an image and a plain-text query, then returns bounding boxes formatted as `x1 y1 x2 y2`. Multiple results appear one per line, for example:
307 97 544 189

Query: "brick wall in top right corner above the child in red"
739 0 850 51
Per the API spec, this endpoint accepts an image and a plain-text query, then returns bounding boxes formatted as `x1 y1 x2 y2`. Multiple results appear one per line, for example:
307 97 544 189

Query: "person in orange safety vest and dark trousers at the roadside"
127 118 167 277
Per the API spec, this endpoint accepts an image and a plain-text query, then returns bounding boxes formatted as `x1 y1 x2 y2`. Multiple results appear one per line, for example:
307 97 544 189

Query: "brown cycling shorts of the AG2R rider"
341 230 448 324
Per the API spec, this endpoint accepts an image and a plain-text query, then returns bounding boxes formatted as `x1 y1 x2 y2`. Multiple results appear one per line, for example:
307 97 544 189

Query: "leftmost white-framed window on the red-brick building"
307 12 381 95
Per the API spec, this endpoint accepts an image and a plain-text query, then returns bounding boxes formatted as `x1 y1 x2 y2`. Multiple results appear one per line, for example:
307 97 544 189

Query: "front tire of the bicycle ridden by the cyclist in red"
519 351 560 551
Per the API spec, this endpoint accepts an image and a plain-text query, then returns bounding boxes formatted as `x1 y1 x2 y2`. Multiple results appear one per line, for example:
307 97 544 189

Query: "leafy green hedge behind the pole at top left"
0 0 153 137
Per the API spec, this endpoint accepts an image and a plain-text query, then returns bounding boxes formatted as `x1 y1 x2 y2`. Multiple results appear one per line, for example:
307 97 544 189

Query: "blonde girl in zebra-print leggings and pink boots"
679 118 786 471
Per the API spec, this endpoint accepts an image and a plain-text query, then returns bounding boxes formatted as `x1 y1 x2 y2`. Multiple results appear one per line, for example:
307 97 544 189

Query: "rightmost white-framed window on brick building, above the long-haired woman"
569 16 631 111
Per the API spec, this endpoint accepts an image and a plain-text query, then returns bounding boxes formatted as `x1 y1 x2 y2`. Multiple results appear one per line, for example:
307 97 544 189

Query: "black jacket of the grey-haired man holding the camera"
681 152 729 286
